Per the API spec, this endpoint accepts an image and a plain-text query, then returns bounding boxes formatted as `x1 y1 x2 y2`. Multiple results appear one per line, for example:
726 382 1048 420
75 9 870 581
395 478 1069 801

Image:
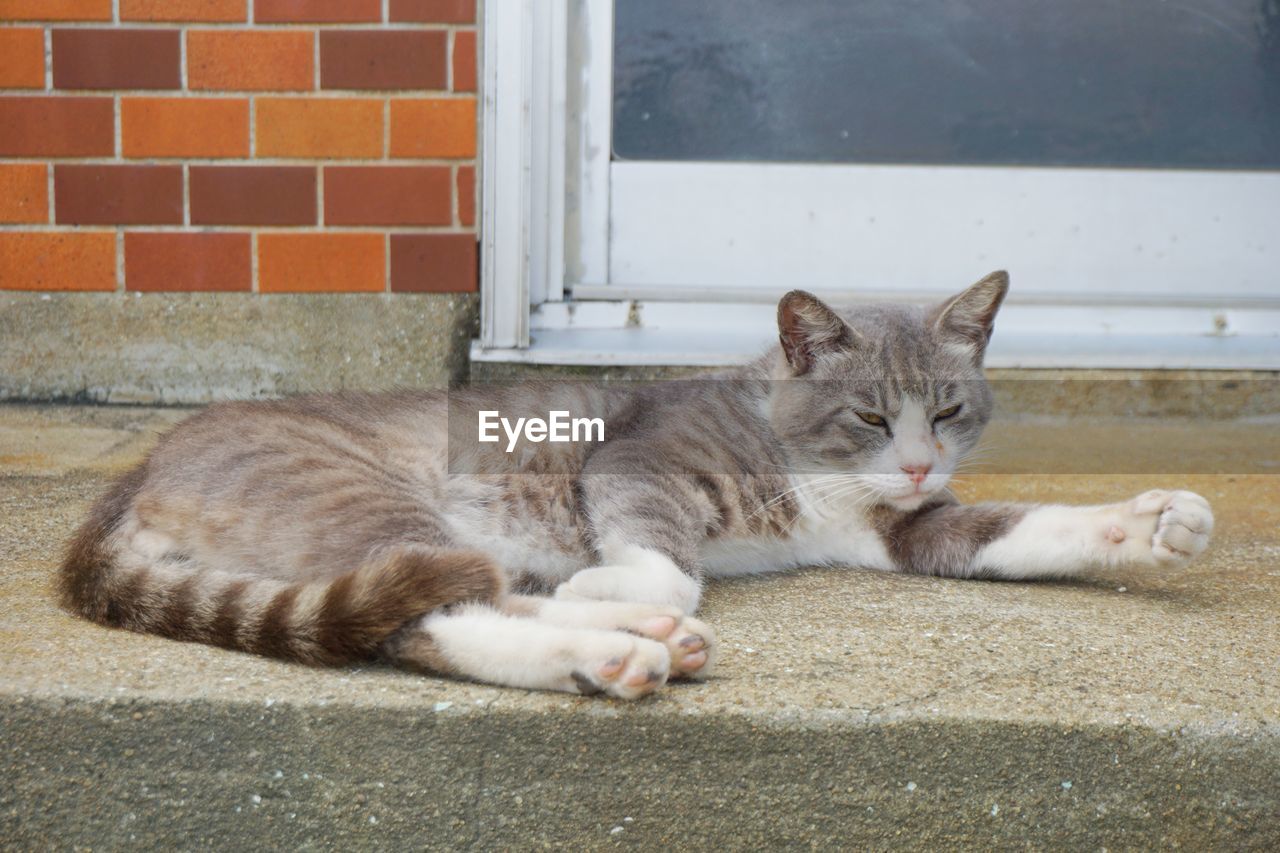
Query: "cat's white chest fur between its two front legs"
701 514 893 578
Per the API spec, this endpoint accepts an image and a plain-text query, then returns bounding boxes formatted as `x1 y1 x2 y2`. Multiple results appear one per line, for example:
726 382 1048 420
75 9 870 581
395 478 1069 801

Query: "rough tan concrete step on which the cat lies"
0 405 1280 850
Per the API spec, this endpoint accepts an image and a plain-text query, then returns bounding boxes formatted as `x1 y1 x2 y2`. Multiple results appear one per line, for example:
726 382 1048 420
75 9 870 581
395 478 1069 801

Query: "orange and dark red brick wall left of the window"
0 0 476 293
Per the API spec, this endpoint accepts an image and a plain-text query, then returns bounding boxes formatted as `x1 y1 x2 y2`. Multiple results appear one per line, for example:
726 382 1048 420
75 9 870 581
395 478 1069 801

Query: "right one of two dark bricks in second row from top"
320 29 448 90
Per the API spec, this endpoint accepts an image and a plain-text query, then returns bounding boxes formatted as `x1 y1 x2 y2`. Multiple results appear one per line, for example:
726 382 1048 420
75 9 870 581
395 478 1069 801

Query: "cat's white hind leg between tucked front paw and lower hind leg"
499 596 719 679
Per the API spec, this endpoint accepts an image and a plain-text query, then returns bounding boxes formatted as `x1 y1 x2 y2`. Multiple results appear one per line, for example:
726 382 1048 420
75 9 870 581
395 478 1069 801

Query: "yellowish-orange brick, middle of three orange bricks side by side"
257 97 383 158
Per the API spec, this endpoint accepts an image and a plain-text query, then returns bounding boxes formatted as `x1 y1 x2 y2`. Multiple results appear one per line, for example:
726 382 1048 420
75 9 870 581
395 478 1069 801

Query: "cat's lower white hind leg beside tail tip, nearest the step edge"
380 605 671 699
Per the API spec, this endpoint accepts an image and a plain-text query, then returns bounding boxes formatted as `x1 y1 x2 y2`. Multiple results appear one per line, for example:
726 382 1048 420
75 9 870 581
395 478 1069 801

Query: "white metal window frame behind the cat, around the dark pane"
472 0 1280 369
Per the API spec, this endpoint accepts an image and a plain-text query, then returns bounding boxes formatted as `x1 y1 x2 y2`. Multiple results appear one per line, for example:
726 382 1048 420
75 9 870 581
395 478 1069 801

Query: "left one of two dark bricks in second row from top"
54 29 182 88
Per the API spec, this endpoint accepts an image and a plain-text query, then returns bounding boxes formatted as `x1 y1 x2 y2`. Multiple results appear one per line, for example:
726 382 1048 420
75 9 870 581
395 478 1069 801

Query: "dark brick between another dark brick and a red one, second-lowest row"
189 165 316 225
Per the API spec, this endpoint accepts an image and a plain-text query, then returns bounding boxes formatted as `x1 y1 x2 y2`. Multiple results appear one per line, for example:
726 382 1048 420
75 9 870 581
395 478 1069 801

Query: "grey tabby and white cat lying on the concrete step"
59 273 1213 699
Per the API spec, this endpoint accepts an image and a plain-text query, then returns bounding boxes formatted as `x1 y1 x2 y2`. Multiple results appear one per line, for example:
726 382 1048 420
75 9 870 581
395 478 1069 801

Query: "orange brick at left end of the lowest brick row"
0 231 115 291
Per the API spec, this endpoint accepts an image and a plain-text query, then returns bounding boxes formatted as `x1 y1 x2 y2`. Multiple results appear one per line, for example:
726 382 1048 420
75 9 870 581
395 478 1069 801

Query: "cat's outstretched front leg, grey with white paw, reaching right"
878 491 1213 580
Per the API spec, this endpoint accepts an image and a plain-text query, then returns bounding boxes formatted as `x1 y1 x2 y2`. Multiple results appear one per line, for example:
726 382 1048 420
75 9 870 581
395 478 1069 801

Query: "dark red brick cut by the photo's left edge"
0 97 115 158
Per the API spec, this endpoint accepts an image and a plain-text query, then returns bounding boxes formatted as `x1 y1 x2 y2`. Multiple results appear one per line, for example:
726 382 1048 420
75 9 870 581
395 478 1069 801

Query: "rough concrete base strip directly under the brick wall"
0 292 479 405
